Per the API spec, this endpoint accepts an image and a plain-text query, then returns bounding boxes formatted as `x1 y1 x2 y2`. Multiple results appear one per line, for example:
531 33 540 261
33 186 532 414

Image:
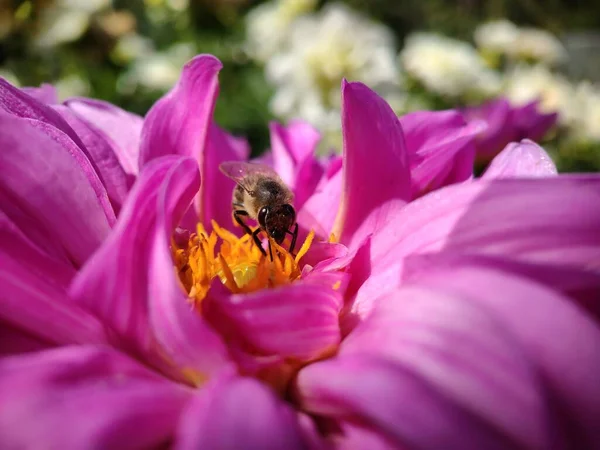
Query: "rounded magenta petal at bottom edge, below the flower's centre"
175 377 308 450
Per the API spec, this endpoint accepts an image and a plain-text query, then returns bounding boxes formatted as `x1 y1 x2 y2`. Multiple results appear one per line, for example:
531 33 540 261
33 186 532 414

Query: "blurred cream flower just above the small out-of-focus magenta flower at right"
505 65 580 126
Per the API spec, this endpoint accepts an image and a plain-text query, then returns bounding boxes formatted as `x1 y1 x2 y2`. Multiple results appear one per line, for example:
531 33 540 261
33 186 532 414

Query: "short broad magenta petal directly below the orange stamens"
207 272 346 361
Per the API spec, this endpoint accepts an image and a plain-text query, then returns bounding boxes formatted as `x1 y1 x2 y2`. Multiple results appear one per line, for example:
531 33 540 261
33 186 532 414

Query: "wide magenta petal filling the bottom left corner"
0 347 191 449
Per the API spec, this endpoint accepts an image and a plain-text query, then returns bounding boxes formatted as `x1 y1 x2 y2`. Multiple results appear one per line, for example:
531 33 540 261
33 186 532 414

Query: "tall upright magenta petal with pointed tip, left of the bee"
140 55 222 167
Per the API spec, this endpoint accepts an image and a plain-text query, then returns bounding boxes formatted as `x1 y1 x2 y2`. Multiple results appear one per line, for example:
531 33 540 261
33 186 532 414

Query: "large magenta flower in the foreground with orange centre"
0 56 600 449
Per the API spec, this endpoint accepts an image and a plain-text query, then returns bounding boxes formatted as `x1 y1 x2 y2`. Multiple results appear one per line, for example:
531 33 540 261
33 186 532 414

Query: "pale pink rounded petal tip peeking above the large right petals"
481 139 557 179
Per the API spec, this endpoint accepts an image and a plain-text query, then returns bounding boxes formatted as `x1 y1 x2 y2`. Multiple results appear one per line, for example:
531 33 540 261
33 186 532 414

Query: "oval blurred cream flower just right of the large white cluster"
400 33 500 97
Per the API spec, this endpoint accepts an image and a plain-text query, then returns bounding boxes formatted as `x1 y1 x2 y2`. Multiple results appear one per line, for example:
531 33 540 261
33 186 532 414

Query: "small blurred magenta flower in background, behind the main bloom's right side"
464 98 558 163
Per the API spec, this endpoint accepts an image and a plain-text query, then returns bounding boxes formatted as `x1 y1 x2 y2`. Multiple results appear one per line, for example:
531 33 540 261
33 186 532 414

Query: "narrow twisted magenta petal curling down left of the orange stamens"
148 159 229 381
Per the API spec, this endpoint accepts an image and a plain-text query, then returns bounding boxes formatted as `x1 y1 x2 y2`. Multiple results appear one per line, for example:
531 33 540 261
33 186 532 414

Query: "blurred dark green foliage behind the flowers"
0 0 600 165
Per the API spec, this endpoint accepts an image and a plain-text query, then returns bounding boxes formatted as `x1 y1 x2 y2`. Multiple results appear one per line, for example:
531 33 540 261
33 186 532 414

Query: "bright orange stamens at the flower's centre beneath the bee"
172 221 314 303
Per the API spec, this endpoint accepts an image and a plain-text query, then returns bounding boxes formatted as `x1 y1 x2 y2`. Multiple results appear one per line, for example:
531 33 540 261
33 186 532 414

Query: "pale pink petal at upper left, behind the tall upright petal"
64 98 144 177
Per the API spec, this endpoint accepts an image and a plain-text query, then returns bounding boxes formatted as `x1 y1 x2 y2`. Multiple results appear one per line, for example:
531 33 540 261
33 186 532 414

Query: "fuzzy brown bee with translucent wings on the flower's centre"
219 161 298 260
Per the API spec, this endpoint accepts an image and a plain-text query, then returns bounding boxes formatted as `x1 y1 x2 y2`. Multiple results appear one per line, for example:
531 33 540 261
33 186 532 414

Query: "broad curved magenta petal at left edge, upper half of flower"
0 113 115 266
